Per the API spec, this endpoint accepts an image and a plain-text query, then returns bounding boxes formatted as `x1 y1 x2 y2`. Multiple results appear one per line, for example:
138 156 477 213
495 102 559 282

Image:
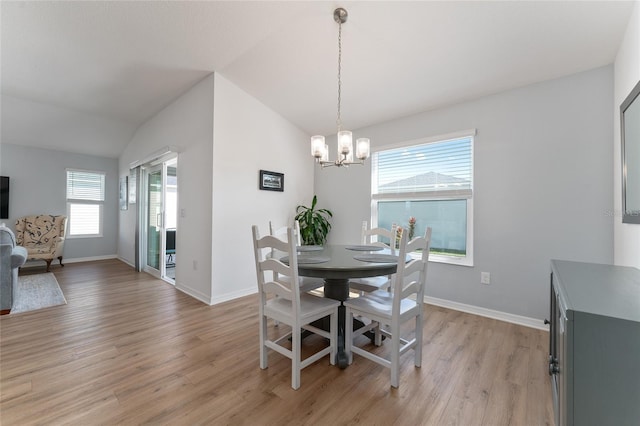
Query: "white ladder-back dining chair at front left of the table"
252 225 340 389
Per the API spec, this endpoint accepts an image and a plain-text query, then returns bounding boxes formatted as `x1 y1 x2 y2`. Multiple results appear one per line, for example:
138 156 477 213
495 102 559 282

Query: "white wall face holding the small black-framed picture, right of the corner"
211 74 314 303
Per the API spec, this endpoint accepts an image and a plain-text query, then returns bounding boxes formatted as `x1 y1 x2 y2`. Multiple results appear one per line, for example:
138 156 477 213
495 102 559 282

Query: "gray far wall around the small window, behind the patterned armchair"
0 142 118 259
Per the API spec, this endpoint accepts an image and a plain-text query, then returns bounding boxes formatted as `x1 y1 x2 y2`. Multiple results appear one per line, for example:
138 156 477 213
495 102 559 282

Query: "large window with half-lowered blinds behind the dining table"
371 130 475 266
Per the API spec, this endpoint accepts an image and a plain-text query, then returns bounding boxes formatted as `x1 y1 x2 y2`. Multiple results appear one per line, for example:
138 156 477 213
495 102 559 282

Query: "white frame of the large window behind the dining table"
371 129 477 267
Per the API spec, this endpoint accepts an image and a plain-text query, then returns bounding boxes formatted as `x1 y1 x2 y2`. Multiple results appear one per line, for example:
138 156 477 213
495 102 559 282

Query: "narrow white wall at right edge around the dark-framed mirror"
613 1 640 268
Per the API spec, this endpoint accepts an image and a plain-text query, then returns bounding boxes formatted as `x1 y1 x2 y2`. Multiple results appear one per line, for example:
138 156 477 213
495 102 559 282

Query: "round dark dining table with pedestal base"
298 244 398 368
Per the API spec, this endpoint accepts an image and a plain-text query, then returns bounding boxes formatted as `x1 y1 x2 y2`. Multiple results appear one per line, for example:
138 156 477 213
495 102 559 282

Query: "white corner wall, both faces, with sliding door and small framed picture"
119 74 313 304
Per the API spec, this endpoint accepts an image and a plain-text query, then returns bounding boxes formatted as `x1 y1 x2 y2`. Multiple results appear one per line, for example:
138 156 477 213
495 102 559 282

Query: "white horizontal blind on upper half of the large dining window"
372 136 473 197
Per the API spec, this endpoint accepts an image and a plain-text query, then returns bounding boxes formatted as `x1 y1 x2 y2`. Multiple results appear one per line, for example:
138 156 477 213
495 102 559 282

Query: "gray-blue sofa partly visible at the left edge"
0 224 27 315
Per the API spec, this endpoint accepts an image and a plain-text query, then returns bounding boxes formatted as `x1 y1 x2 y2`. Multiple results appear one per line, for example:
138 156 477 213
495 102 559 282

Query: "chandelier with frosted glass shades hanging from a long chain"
311 7 370 168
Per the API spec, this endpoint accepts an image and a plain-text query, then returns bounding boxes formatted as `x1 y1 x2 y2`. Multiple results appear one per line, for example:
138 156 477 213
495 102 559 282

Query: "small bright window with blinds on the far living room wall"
67 169 105 238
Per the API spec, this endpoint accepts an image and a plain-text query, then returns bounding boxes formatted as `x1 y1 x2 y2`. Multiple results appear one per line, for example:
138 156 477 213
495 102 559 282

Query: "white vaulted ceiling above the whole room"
0 0 633 157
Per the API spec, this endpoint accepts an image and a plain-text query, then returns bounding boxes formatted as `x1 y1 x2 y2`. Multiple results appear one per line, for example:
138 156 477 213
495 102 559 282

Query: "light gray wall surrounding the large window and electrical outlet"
315 66 613 319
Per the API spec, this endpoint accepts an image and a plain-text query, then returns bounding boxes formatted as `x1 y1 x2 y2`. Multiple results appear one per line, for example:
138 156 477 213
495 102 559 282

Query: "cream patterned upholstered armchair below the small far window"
16 215 67 272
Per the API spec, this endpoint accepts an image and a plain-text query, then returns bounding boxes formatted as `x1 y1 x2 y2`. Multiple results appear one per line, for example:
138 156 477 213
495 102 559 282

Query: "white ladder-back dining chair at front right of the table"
344 228 431 388
